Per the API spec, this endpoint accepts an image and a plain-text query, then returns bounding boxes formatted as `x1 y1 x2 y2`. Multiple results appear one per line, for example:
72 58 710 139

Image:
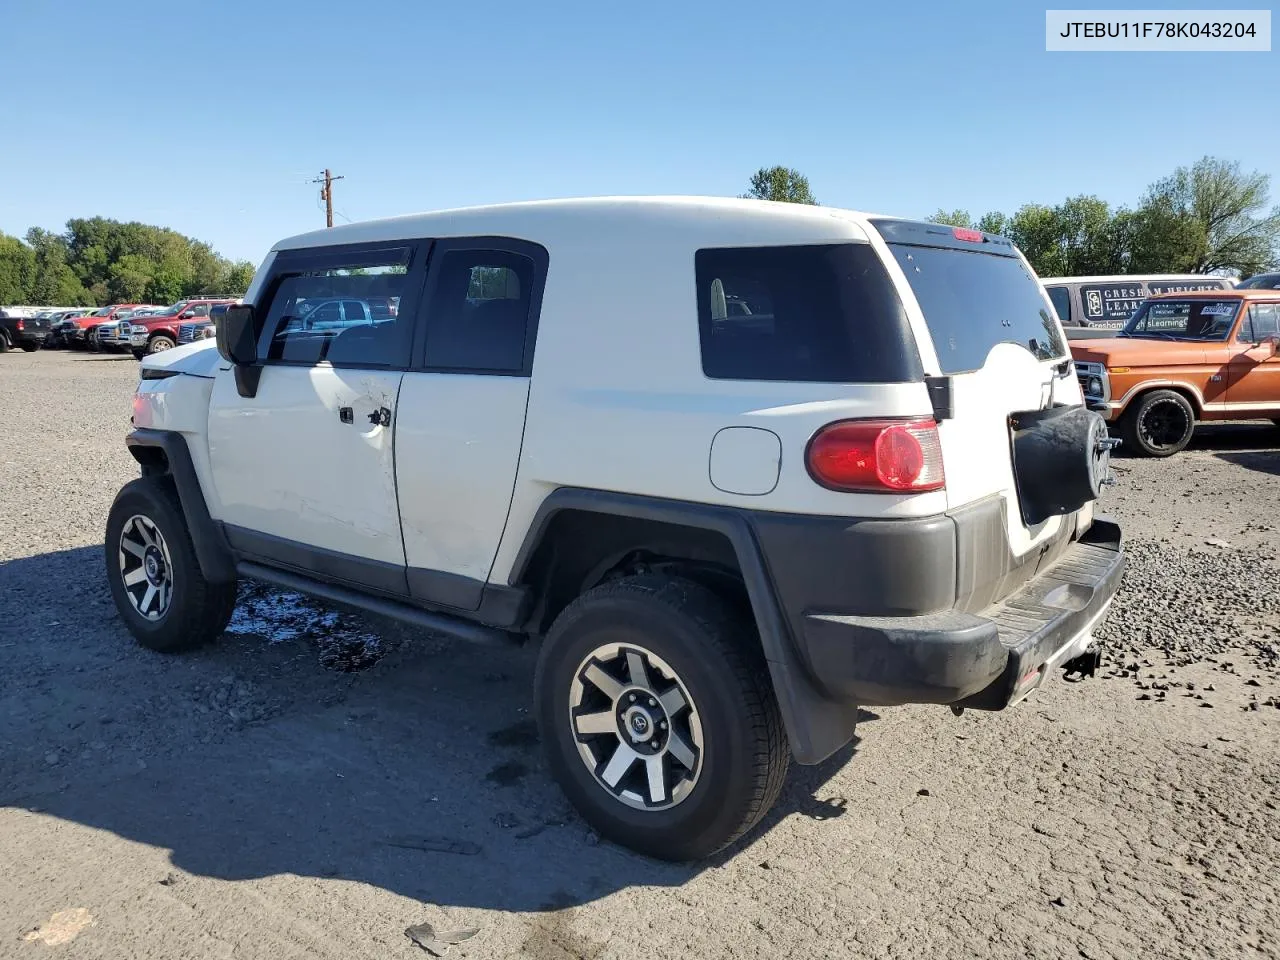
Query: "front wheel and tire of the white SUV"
105 476 236 653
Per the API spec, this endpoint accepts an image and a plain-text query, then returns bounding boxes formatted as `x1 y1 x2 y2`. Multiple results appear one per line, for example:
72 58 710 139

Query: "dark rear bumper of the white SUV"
762 518 1125 710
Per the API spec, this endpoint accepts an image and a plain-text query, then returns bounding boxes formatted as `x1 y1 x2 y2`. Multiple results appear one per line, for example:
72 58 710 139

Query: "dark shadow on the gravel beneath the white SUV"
0 548 876 911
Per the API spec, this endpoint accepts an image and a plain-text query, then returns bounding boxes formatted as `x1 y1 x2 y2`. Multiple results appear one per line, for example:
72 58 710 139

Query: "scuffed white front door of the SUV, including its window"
209 243 426 594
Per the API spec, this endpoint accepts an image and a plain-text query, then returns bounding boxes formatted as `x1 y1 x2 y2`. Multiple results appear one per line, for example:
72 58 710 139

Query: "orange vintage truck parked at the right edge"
1070 289 1280 457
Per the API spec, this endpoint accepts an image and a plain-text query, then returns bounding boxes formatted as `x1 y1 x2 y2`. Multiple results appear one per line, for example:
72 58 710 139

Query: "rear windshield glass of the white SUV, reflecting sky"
888 243 1066 374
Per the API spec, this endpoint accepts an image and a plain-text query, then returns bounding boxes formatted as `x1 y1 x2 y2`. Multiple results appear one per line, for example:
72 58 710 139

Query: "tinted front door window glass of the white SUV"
260 247 412 367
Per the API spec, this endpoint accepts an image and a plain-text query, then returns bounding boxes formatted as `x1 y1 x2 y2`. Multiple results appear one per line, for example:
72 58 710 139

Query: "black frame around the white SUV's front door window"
253 238 433 371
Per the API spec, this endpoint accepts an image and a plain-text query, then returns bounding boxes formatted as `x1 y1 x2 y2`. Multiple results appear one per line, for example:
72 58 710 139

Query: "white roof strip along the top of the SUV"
273 197 900 250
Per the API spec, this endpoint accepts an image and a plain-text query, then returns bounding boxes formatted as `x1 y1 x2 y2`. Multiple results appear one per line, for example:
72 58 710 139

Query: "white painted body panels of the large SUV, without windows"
136 198 1080 593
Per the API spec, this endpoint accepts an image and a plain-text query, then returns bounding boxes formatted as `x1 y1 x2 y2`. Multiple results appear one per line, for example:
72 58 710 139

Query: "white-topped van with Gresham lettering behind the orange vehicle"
1041 274 1234 340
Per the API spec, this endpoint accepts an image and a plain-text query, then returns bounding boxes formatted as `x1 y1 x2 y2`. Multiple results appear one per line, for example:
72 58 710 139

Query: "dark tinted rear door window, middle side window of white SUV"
425 248 536 374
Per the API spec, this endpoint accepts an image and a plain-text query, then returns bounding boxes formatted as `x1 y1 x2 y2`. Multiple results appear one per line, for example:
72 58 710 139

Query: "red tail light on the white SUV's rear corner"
805 419 945 493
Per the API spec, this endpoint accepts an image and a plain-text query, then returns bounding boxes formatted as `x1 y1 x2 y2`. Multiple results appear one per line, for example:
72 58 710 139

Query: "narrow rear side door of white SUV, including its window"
396 237 548 611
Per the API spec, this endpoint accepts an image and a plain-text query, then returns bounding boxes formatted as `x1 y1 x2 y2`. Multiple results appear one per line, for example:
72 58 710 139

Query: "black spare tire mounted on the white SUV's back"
1010 407 1116 525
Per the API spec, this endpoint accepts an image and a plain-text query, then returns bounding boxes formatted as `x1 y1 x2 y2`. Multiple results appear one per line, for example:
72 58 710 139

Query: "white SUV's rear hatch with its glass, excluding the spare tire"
872 219 1080 579
